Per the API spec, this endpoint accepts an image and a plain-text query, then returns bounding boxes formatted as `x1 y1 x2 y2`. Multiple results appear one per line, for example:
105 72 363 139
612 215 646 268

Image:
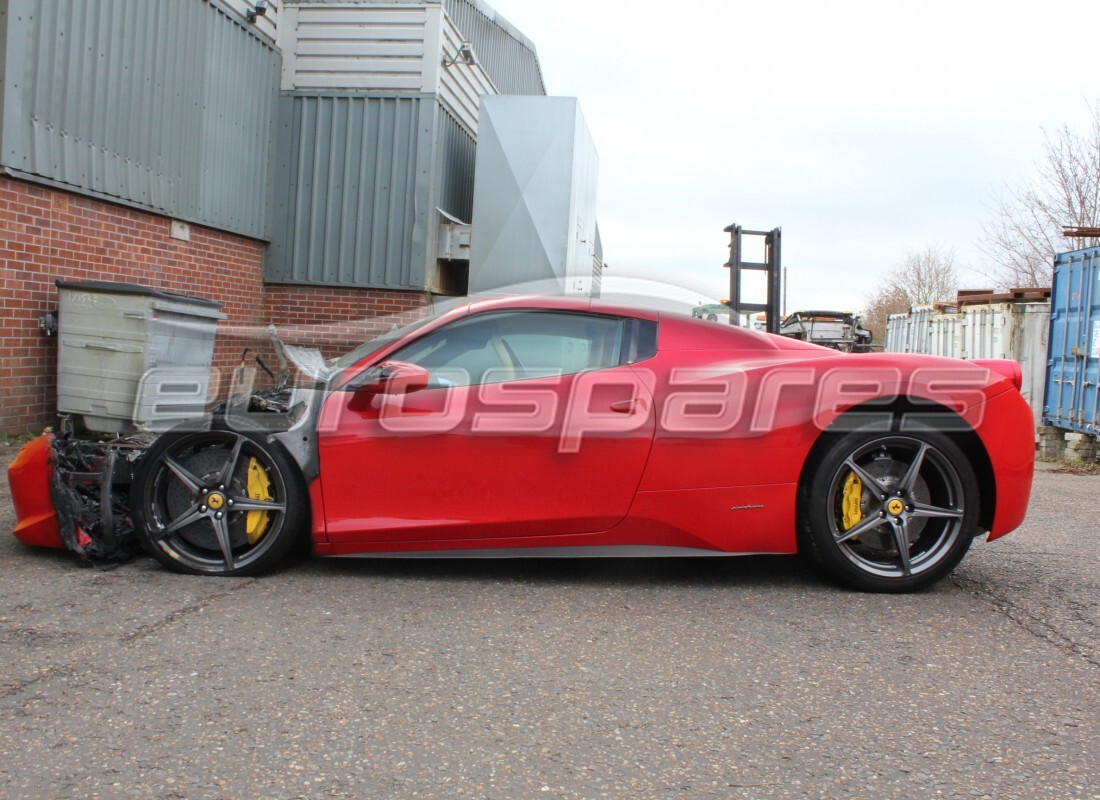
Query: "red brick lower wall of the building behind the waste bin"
0 177 428 434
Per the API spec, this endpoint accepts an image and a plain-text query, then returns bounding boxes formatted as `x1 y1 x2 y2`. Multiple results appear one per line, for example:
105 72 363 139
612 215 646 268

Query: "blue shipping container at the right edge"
1043 248 1100 435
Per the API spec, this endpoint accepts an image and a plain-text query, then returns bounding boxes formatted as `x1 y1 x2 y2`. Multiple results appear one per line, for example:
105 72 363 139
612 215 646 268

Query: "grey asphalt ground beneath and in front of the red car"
0 449 1100 800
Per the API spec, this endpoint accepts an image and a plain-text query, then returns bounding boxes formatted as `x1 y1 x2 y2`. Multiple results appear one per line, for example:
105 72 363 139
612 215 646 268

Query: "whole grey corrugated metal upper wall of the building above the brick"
0 0 545 289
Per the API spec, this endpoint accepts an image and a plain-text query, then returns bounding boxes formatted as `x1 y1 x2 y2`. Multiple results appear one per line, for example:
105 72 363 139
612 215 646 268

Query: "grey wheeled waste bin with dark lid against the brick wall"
57 281 226 434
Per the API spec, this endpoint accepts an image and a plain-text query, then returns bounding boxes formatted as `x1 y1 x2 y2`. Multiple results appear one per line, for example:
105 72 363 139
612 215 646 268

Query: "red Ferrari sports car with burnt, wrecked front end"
9 297 1034 592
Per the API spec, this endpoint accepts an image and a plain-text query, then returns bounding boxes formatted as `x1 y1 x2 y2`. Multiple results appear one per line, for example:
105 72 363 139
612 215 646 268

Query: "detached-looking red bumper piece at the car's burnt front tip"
8 434 65 549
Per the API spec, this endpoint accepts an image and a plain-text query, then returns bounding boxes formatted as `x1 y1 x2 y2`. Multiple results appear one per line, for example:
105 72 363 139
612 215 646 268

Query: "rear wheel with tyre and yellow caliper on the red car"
799 430 978 592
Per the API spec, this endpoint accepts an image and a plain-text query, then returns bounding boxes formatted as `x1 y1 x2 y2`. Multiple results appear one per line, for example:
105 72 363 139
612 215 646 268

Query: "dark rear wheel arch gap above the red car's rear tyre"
798 397 997 539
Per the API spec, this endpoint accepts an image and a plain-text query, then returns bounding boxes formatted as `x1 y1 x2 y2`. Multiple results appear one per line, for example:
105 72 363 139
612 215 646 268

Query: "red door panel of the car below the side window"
319 366 655 546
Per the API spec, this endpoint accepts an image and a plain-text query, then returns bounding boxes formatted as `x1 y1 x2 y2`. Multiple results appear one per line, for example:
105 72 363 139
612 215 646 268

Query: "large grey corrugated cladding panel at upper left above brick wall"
2 0 279 238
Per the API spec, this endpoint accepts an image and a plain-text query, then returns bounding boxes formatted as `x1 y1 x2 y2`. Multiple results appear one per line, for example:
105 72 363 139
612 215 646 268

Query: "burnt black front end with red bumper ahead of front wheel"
8 432 155 561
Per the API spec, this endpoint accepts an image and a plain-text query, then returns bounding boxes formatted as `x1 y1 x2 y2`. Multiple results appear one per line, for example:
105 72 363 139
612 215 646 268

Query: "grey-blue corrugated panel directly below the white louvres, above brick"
266 95 435 289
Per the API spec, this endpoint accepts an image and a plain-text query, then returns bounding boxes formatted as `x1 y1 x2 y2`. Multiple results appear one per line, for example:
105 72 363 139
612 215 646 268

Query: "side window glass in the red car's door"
393 311 624 386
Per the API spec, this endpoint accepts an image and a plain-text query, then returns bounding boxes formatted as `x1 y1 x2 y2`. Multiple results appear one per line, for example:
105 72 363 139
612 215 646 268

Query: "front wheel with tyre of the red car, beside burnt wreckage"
130 429 309 576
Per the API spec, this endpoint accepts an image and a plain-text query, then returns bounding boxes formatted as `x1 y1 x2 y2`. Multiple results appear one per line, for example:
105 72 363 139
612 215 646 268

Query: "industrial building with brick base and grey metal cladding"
0 0 585 432
